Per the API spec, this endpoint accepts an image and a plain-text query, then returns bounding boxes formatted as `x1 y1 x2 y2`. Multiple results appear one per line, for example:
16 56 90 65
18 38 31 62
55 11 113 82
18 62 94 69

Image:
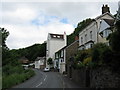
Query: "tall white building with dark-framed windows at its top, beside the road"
46 33 67 67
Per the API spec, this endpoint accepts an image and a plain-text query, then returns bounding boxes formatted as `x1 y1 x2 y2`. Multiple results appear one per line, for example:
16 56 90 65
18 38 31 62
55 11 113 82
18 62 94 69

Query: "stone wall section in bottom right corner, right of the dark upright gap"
90 67 120 88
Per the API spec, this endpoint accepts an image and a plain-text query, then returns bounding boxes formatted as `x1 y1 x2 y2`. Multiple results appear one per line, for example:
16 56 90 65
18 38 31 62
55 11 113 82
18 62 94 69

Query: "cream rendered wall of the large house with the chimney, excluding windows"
79 14 113 50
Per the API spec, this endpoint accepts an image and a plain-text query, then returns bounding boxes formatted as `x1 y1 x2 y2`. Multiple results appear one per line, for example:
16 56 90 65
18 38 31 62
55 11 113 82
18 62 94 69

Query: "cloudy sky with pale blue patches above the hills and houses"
0 0 119 49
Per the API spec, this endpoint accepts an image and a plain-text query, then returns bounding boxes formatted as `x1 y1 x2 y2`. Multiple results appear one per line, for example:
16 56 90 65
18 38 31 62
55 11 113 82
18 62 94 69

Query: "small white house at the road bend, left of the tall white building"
35 57 45 69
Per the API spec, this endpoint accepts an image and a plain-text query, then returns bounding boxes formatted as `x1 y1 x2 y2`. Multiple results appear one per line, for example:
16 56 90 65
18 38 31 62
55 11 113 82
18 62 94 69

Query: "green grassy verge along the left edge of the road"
2 69 35 89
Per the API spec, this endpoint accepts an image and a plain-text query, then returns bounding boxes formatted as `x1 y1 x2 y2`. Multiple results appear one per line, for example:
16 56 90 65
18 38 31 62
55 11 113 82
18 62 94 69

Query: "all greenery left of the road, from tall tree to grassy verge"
0 28 34 89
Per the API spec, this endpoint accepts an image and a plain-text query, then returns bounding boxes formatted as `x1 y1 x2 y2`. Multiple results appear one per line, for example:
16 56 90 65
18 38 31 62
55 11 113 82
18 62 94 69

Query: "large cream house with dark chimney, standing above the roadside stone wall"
79 5 114 50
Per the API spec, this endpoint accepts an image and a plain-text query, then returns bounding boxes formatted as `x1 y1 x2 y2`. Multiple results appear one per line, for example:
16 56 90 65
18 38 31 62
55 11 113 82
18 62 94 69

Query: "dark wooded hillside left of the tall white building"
15 43 46 61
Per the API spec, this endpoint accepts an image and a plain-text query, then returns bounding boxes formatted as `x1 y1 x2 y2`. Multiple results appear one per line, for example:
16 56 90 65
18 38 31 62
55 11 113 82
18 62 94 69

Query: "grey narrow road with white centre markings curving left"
13 69 79 88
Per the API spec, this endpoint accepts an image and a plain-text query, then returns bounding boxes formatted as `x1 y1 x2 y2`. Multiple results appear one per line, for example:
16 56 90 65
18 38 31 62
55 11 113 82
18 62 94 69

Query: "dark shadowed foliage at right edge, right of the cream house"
109 16 120 72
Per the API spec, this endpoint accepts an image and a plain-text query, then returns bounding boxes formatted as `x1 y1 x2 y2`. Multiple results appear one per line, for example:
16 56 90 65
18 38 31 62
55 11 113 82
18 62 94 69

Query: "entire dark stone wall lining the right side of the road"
72 66 120 88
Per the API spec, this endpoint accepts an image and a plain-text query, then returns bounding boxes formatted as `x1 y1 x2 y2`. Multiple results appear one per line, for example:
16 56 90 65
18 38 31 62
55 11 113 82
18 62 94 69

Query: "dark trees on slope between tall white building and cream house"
67 18 93 45
